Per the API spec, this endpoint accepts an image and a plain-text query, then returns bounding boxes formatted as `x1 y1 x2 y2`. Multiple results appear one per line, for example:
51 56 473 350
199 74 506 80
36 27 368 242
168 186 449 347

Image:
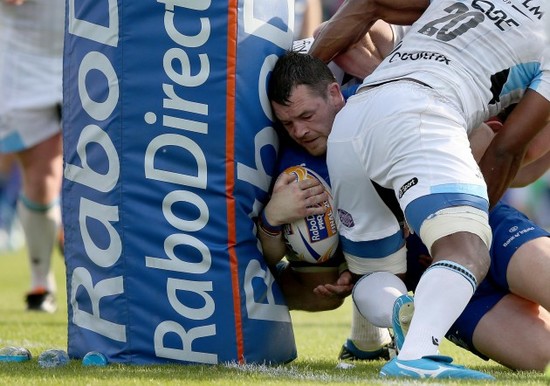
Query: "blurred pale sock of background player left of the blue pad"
17 197 61 292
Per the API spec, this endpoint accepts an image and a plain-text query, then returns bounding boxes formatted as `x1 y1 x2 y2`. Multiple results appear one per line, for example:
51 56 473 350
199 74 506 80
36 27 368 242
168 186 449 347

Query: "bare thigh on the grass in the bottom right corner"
473 294 550 370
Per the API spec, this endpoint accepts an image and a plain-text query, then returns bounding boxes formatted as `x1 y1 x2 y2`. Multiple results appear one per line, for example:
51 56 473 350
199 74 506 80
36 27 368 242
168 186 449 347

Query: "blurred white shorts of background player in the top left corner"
0 0 65 152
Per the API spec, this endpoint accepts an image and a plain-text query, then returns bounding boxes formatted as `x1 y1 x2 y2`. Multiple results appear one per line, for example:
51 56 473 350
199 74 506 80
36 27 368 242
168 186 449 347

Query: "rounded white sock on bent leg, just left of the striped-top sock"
352 272 407 327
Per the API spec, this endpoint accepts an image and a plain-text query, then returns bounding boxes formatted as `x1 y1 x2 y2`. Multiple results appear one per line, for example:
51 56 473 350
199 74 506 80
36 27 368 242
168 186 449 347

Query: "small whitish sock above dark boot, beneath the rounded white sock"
349 304 391 351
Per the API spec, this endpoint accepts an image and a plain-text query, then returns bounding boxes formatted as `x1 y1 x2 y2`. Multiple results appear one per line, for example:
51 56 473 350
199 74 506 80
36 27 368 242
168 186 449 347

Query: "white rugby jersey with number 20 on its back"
361 0 550 129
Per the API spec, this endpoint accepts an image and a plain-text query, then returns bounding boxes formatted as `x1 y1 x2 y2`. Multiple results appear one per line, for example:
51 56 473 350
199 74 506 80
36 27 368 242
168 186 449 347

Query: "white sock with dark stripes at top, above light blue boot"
398 260 476 360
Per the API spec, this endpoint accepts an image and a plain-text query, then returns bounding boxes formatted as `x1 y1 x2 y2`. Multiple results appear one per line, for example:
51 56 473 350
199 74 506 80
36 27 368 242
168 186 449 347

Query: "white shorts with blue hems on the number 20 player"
327 81 488 268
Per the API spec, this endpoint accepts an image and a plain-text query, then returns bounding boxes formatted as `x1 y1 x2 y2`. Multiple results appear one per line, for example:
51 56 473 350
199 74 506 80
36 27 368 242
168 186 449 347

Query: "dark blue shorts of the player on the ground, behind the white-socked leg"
406 203 550 360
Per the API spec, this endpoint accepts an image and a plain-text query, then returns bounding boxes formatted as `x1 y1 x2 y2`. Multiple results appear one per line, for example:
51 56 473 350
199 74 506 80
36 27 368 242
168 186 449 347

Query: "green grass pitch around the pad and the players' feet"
0 246 550 386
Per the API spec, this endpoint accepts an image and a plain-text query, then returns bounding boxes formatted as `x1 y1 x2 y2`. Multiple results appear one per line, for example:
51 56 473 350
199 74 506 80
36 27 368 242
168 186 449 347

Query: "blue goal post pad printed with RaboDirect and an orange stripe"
63 0 296 364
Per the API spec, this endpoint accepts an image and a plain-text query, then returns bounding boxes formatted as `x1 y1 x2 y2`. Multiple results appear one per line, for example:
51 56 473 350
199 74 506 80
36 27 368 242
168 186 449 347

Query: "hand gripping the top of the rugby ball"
264 173 328 225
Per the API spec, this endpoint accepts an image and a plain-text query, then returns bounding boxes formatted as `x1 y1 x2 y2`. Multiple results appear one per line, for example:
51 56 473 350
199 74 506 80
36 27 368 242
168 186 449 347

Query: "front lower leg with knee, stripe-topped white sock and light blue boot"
380 228 493 379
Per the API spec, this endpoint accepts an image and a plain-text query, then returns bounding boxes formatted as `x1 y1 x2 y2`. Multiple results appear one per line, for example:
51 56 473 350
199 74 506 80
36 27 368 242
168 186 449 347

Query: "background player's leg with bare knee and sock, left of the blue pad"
18 133 63 312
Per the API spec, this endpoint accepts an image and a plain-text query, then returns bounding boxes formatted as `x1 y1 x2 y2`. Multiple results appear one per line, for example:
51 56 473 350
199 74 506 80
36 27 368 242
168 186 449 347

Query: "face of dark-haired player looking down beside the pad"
272 83 344 156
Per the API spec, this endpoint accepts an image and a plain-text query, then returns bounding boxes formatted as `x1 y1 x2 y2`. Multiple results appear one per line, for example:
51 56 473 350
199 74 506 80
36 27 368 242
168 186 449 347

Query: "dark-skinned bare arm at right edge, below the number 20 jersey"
479 89 550 205
